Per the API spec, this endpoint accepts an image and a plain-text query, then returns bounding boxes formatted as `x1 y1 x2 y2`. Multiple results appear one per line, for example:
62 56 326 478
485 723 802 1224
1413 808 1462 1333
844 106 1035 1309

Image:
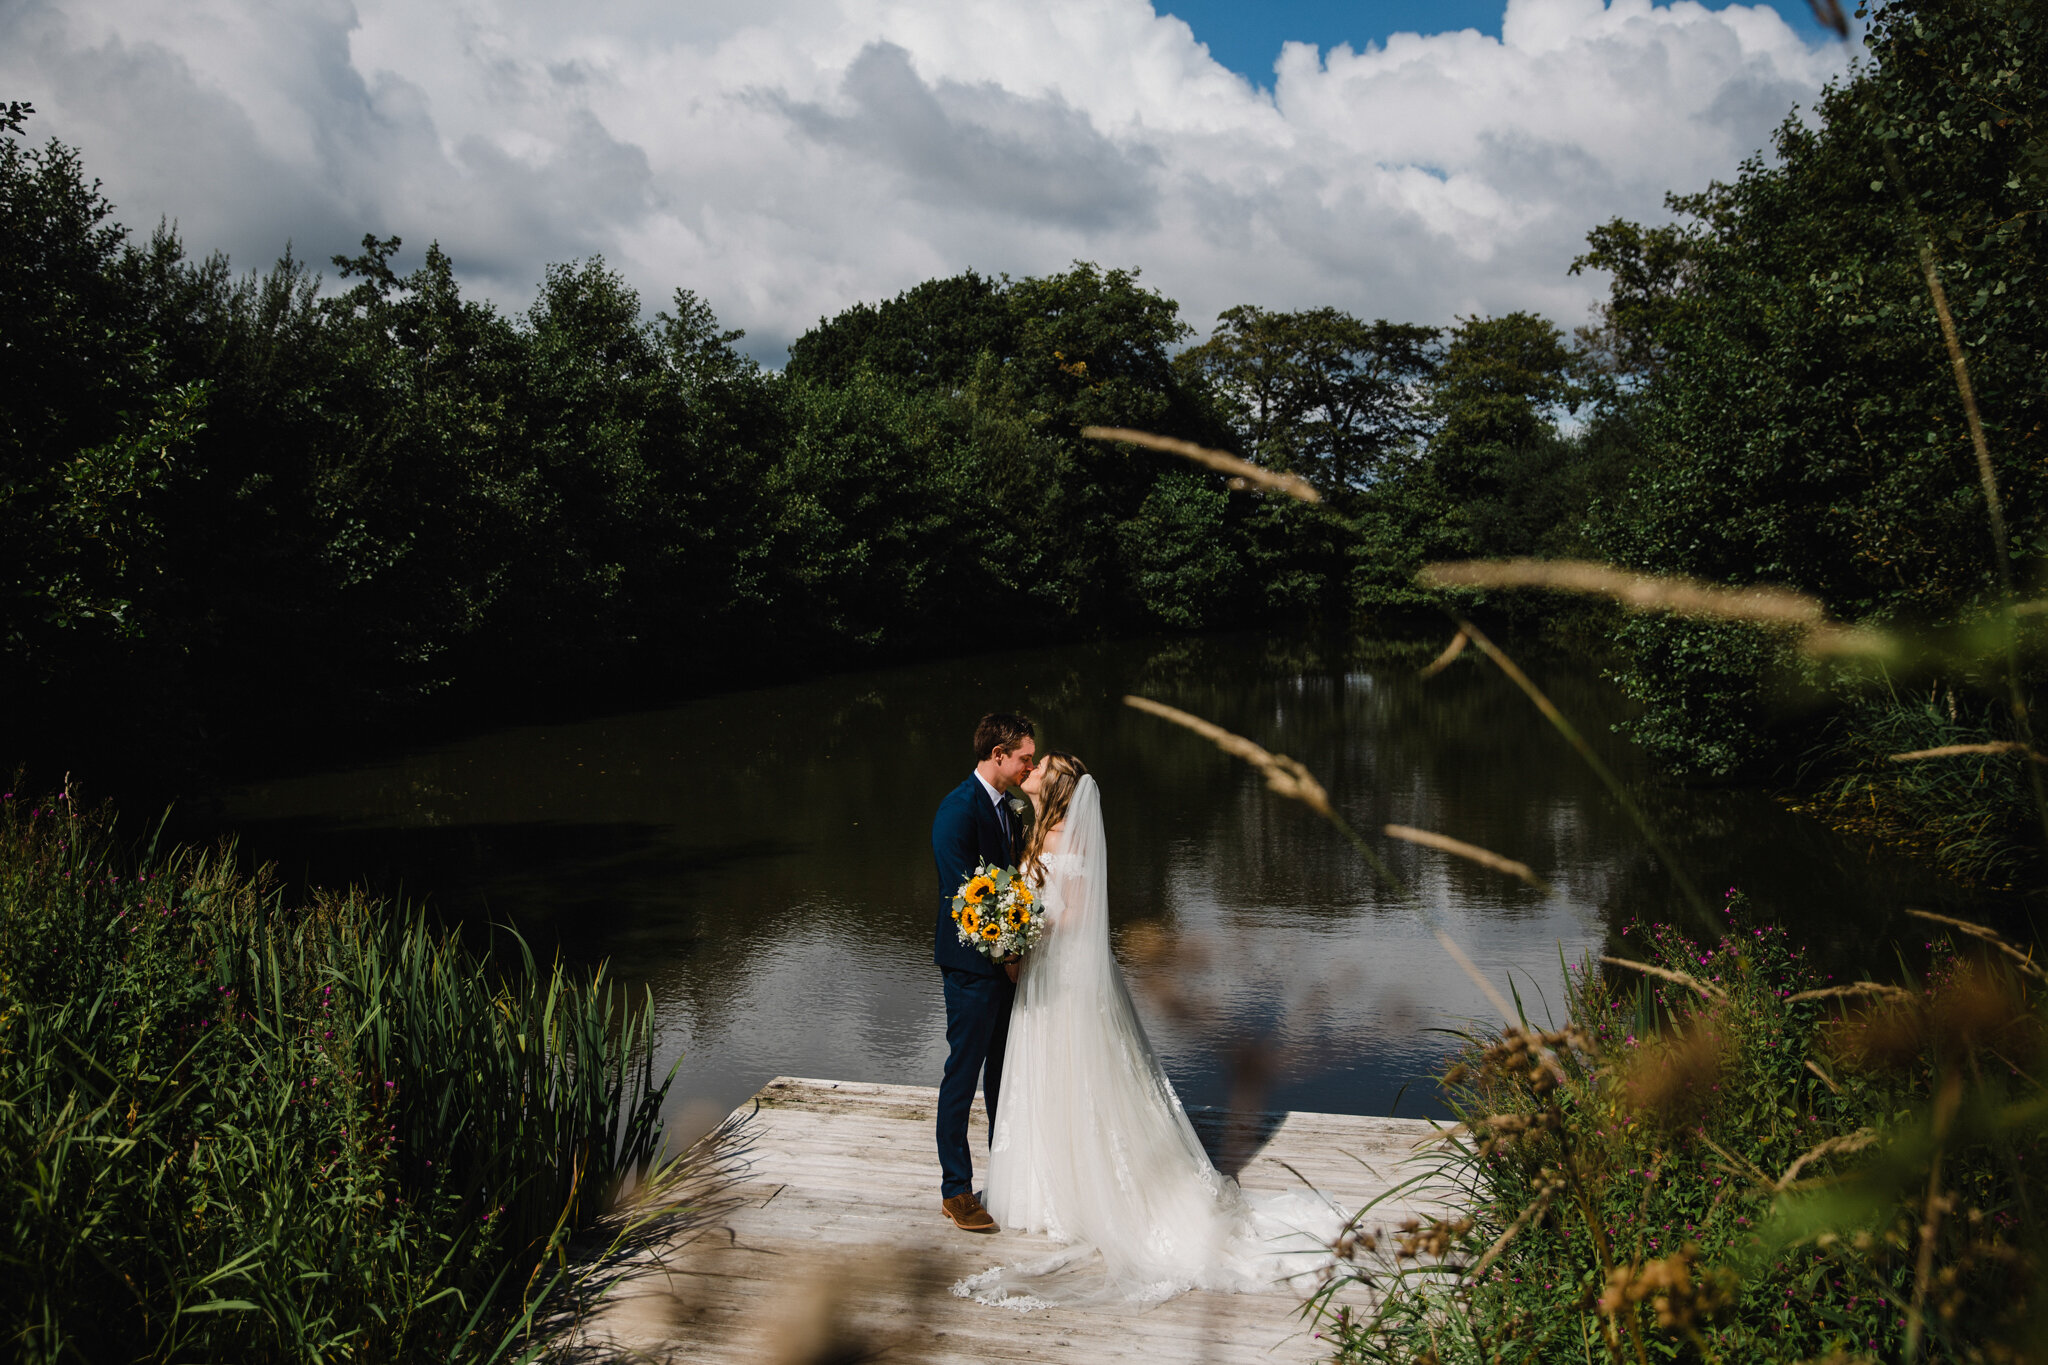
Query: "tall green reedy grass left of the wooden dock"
0 796 674 1363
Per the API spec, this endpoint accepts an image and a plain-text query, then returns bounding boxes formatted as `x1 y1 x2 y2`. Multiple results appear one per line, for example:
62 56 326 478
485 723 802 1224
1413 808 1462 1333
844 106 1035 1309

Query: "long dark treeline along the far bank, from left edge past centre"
0 104 1569 806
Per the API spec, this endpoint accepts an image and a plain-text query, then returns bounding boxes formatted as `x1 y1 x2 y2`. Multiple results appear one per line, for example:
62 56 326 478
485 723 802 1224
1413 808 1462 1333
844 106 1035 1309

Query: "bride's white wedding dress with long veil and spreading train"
954 778 1343 1308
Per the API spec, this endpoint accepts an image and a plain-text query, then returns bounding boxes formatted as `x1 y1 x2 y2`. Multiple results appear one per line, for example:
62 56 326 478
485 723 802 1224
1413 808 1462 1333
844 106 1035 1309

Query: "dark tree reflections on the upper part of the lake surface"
228 634 1998 1080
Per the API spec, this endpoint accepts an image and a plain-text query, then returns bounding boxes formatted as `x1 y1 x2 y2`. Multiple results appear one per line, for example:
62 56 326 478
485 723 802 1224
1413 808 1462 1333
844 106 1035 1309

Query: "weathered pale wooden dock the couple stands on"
578 1076 1436 1365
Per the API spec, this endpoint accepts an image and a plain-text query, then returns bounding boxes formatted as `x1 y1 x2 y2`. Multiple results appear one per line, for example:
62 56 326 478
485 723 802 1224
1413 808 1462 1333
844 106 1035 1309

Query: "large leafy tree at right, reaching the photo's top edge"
1581 0 2048 776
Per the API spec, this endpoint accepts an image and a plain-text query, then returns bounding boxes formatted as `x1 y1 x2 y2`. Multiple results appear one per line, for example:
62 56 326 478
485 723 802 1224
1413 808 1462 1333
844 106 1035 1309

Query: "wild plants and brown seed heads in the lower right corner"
1323 890 2048 1363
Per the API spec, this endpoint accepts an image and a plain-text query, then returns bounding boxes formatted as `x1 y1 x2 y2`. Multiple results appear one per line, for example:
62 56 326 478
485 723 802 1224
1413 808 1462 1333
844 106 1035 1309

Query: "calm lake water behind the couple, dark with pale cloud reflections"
231 636 1970 1128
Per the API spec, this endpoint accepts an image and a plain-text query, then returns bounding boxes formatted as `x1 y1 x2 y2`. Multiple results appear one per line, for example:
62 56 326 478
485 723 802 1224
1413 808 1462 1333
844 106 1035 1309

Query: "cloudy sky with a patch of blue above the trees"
0 0 1847 364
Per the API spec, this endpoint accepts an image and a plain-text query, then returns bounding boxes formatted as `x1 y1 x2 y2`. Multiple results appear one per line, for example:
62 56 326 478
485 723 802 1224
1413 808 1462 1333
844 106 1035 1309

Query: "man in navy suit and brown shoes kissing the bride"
932 712 1038 1232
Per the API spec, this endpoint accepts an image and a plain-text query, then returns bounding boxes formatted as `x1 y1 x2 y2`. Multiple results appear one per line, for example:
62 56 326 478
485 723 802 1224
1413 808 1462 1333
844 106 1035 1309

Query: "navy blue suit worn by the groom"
932 774 1024 1199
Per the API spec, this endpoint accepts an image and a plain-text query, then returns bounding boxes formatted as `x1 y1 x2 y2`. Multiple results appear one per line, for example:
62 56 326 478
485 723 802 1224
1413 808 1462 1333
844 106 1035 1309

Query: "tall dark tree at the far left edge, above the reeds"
0 102 209 785
